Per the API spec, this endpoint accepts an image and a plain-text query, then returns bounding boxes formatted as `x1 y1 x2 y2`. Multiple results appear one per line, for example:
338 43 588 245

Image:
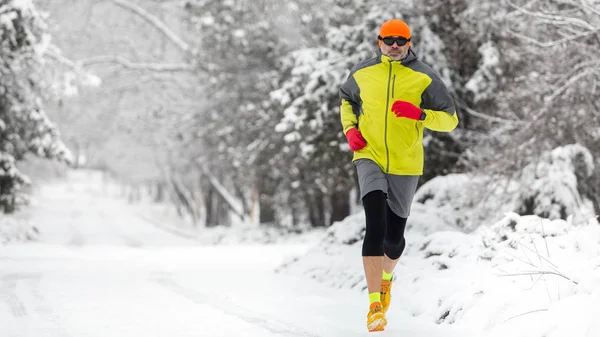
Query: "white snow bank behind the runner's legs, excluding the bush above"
277 206 600 337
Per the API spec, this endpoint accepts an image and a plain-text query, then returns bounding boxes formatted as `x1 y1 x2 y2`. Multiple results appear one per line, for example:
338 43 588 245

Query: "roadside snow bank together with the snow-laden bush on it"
277 145 600 337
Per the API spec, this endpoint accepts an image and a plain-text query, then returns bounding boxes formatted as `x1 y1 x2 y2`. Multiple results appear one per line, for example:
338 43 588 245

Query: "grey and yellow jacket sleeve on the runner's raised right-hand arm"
421 73 458 132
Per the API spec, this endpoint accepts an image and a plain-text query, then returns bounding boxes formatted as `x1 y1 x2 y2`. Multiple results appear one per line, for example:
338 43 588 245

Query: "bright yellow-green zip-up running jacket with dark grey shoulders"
340 50 458 175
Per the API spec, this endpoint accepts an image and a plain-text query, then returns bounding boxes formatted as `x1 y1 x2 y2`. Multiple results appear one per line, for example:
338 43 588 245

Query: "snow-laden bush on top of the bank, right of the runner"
409 144 594 231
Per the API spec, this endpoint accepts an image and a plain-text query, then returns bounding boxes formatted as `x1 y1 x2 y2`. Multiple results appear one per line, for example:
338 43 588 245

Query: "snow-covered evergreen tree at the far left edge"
0 0 71 213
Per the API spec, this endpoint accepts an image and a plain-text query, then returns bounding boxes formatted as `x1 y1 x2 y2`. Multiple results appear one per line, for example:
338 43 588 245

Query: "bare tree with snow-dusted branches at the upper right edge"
467 0 600 213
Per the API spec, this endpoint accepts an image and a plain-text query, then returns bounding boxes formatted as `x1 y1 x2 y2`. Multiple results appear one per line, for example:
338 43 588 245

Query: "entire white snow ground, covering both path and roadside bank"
0 168 600 337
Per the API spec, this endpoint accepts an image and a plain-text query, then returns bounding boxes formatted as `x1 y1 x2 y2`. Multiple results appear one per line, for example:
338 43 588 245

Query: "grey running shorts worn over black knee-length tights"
354 159 420 218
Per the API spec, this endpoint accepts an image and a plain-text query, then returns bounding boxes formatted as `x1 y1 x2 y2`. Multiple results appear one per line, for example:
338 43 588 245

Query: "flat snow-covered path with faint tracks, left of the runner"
0 173 474 337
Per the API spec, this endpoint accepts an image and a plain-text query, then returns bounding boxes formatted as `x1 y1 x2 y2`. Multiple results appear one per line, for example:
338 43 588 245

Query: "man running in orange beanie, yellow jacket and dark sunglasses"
340 20 458 331
